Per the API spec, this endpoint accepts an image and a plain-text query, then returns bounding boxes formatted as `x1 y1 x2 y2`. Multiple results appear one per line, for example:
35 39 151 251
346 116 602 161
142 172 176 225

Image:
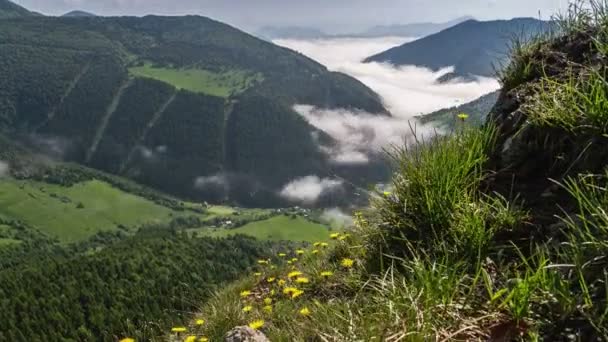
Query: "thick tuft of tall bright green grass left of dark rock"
375 127 494 253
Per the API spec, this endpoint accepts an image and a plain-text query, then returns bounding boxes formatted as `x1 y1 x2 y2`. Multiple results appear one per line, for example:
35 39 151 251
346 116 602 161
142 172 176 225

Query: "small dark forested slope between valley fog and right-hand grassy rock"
416 91 499 129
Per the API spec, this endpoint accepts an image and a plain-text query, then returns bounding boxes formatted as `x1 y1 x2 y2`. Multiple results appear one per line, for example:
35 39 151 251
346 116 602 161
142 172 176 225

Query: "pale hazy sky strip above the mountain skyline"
13 0 568 33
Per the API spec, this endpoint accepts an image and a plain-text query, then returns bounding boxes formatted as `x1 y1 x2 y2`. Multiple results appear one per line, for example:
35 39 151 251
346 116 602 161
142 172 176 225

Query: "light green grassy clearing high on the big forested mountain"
129 64 263 97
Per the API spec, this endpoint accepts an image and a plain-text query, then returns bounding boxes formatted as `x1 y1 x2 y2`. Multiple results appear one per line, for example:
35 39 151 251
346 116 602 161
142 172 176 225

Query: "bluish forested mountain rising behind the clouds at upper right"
365 18 552 77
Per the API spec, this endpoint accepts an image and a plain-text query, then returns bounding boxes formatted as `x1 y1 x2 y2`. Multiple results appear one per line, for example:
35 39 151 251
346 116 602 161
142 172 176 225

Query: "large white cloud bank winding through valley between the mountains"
275 37 499 164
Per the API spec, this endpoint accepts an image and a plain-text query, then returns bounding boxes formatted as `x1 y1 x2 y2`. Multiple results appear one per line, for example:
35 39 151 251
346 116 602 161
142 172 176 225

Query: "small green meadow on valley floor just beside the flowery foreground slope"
196 215 330 242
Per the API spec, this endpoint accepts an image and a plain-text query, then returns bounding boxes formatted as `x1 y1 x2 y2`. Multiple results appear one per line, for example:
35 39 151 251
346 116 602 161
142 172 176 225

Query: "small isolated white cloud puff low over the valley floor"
280 176 342 205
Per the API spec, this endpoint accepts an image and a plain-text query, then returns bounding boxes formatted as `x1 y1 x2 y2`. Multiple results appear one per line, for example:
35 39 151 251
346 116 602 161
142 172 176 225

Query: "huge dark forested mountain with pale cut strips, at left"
0 16 386 206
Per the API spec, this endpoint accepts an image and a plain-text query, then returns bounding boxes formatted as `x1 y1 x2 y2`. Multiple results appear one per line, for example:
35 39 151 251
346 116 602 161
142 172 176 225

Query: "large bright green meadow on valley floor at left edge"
0 179 204 242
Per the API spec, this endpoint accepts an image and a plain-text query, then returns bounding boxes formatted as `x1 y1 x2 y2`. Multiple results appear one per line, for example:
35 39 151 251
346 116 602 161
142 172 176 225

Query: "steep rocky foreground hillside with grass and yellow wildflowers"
178 3 608 341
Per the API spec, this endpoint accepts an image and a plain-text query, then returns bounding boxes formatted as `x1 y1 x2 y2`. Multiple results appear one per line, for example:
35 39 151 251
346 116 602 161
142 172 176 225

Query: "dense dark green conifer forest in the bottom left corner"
0 231 268 341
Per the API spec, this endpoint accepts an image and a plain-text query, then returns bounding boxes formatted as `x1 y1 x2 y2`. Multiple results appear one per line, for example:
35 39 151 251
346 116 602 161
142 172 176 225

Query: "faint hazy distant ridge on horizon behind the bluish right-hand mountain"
360 16 474 37
